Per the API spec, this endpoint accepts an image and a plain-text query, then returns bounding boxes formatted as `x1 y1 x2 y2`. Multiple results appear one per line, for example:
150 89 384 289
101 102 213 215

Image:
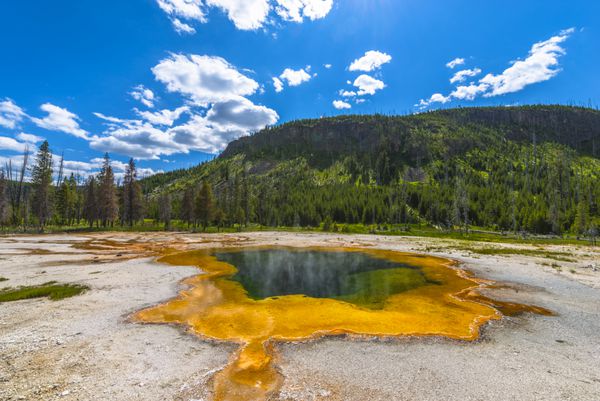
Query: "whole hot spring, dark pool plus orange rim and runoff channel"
134 247 549 400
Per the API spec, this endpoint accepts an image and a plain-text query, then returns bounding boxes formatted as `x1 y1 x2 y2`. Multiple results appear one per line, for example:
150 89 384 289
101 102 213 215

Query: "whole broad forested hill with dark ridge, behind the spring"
146 106 600 234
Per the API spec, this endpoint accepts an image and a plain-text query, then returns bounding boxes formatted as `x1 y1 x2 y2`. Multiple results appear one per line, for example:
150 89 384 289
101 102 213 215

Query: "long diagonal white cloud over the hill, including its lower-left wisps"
417 28 574 108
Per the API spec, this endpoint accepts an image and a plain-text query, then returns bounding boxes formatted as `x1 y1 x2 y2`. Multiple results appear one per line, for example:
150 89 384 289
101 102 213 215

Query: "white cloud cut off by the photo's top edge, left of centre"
156 0 333 34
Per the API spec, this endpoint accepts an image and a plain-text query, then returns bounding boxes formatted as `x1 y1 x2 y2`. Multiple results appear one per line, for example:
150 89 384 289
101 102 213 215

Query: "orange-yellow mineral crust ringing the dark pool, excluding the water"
134 248 549 401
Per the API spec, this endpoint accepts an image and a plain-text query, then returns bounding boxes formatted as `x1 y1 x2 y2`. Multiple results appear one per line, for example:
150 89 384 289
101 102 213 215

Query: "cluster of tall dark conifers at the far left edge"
0 141 144 230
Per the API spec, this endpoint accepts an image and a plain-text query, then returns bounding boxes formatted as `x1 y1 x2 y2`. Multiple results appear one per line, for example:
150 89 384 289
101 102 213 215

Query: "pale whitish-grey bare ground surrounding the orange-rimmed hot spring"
0 232 600 401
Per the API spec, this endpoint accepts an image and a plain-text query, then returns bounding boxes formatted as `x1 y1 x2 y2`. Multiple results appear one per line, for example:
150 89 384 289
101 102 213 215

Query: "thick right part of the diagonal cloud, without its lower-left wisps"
479 28 574 97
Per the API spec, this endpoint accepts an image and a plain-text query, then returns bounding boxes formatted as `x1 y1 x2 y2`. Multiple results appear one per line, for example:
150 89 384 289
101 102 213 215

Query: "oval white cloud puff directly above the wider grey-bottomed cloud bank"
152 54 259 107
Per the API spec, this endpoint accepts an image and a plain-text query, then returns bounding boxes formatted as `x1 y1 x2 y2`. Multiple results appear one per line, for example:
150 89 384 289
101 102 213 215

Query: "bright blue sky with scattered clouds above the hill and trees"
0 0 600 175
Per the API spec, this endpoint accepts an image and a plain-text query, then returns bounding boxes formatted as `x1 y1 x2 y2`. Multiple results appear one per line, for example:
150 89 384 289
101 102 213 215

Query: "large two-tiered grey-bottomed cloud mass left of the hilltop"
90 55 283 160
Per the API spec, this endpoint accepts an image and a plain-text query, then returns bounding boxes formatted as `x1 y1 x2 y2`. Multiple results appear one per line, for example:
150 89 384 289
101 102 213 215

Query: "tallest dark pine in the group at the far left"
31 141 52 230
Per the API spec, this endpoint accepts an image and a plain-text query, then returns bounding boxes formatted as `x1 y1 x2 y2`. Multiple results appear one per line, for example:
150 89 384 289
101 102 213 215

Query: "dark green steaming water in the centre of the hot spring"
215 249 435 309
